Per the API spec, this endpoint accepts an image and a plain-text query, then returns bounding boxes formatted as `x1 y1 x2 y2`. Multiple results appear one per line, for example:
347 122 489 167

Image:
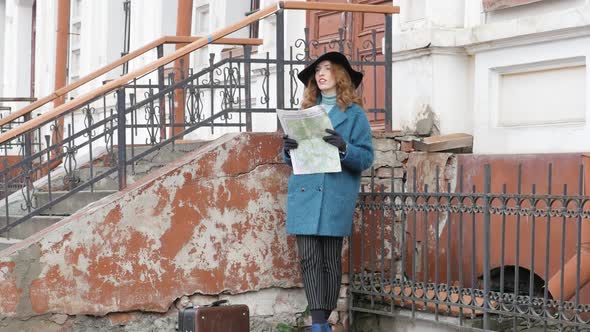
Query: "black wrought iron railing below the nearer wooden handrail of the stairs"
0 10 398 243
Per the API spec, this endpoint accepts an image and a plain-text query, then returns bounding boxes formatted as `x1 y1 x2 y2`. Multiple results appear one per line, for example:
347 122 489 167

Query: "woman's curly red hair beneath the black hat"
301 62 363 112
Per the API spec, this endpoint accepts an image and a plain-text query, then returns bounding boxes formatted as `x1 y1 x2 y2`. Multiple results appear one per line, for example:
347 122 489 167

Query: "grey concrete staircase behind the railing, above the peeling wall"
0 141 207 250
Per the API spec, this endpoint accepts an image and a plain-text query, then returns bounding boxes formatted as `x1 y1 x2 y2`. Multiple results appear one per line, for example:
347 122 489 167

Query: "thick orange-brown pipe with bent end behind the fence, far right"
547 154 590 301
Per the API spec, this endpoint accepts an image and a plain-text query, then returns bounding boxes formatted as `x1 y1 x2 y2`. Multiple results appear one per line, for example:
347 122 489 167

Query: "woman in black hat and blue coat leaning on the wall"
283 52 373 332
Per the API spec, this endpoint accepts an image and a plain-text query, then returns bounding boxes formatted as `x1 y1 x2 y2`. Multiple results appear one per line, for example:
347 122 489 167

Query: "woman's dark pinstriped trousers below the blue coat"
297 235 343 311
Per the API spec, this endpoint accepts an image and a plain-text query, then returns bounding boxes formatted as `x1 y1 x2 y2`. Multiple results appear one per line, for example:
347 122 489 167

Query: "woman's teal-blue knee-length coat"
283 104 373 236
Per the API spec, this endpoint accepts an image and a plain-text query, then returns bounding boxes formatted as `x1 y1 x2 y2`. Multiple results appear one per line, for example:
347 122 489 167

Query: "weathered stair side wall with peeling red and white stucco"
0 134 299 318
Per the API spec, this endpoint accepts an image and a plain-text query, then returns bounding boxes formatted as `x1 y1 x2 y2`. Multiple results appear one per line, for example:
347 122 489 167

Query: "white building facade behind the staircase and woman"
0 0 590 153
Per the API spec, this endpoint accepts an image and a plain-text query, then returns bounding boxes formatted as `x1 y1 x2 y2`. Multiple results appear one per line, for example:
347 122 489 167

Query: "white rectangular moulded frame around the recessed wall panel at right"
474 36 590 153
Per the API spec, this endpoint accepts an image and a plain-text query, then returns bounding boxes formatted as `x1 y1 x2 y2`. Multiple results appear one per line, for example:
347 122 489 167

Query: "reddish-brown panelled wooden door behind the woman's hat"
307 0 391 130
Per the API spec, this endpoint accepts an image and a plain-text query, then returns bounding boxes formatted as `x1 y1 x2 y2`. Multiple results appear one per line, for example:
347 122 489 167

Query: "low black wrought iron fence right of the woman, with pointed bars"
349 164 590 331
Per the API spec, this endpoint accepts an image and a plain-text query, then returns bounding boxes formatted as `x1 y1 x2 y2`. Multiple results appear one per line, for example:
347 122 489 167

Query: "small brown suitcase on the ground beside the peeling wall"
178 300 250 332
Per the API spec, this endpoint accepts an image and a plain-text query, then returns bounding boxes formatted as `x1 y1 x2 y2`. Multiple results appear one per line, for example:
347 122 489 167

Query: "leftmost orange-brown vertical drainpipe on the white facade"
52 0 70 154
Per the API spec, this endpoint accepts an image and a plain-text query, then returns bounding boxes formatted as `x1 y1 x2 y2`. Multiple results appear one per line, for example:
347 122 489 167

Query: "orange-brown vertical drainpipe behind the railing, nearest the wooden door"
170 0 193 136
